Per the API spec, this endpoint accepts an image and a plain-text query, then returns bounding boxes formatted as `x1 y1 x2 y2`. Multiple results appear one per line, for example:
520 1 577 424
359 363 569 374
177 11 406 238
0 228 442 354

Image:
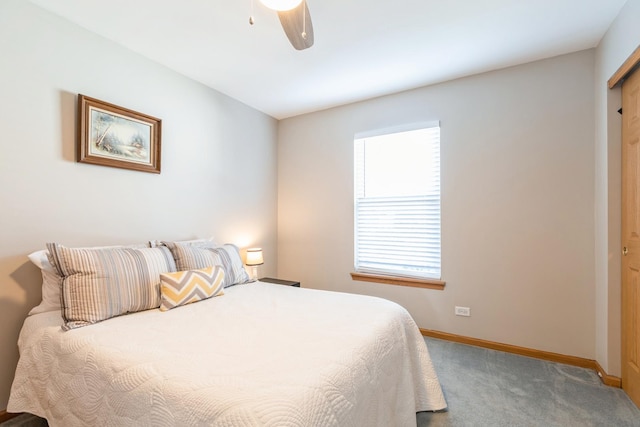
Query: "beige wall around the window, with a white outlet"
278 50 595 359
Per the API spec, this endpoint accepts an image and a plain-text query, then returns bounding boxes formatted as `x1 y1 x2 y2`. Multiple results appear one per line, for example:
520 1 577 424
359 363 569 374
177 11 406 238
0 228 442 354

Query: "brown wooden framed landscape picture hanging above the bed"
77 95 162 173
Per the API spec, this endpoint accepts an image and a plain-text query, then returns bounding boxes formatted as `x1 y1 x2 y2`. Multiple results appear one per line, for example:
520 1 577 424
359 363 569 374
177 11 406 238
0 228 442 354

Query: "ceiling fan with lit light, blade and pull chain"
255 0 313 50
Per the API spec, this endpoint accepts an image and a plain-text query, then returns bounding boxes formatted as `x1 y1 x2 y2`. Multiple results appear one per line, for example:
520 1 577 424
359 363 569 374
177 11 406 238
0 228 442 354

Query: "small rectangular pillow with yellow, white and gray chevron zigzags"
160 265 224 311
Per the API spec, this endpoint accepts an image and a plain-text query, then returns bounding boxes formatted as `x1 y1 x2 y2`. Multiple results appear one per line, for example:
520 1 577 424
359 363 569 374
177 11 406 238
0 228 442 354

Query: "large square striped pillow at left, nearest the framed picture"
47 243 176 330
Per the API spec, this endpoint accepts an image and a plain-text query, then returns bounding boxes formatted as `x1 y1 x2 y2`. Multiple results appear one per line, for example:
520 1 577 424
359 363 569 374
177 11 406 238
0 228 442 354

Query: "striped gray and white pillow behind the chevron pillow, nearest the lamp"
163 242 249 288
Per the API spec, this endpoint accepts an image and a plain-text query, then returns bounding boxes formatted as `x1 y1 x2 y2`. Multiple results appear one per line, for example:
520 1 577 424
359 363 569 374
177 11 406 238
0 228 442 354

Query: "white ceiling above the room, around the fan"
31 0 626 119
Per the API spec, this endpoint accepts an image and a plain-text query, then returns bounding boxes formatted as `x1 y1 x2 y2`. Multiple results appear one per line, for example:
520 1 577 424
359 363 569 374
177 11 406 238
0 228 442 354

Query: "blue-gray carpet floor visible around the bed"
2 338 640 427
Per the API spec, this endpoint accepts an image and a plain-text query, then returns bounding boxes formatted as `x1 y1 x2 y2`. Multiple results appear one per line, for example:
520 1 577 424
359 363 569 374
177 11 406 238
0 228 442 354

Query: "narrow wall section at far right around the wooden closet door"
595 0 640 376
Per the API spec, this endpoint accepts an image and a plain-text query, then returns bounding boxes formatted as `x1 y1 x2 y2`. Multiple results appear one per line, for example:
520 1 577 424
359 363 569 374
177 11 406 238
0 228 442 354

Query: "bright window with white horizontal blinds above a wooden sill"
354 125 440 279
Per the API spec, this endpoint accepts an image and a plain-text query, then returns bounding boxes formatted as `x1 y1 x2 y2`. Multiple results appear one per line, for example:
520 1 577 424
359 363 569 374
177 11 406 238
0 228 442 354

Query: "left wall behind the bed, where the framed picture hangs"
0 0 277 410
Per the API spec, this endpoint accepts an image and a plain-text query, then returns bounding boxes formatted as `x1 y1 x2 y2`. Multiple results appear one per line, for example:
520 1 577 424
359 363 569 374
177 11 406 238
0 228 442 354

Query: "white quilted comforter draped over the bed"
8 283 446 427
